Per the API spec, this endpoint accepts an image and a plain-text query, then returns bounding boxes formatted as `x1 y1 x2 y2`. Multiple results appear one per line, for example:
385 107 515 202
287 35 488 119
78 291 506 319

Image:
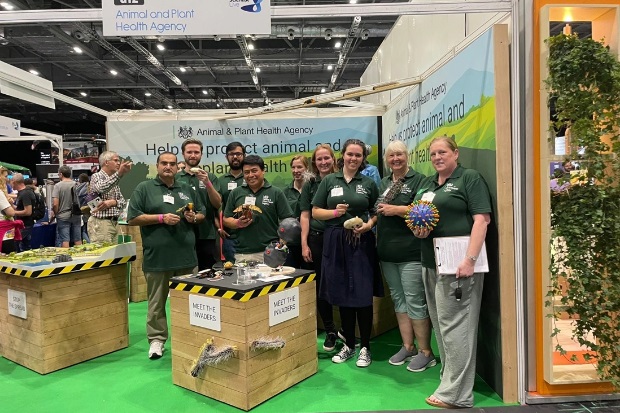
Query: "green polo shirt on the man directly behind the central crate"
224 180 293 254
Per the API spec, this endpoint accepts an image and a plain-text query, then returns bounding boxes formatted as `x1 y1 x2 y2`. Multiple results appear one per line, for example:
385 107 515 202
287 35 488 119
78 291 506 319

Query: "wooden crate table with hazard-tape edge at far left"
0 243 136 374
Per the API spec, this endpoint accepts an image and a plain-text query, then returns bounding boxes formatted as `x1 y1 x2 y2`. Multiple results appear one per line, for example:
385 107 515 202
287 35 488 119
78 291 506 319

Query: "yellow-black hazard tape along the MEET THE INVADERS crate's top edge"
169 273 316 302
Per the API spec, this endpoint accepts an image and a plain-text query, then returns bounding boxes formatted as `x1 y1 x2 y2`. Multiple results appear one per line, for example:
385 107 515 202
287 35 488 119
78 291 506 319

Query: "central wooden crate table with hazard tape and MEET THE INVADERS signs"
170 270 318 410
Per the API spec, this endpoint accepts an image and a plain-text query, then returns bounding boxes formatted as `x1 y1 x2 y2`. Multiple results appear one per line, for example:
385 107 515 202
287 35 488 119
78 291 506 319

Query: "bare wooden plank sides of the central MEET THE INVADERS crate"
170 282 318 411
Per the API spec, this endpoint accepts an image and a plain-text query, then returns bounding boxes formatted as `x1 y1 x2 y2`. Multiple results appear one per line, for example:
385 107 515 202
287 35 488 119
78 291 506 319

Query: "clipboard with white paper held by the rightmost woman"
433 236 489 275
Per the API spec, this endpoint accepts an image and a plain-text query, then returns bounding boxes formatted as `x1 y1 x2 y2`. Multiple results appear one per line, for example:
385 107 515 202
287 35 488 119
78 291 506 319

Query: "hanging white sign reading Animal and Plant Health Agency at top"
101 0 271 37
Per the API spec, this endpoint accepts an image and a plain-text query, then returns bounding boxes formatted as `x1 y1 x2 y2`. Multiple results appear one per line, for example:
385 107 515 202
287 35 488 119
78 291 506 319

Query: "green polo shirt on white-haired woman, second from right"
377 168 426 262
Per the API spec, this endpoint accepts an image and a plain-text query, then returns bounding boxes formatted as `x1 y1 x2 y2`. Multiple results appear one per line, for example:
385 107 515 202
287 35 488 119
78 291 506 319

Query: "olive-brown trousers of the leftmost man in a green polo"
144 267 194 343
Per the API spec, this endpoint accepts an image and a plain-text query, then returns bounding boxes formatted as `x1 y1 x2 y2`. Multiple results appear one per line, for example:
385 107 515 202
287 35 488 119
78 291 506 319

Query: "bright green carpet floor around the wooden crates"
0 303 503 413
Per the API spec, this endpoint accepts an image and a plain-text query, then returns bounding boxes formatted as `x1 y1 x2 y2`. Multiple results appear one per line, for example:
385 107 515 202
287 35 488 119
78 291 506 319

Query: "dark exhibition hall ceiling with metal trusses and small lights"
0 0 406 129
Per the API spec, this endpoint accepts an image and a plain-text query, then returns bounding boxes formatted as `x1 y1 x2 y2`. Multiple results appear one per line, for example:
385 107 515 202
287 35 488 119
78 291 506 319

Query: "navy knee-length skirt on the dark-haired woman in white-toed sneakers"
319 227 384 307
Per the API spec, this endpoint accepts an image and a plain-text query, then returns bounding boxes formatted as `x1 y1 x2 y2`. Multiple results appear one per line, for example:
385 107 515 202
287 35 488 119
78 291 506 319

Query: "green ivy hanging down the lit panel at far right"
546 34 620 388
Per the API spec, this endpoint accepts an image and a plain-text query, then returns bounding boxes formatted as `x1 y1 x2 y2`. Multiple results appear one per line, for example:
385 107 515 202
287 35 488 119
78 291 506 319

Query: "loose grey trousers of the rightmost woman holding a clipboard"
422 268 484 407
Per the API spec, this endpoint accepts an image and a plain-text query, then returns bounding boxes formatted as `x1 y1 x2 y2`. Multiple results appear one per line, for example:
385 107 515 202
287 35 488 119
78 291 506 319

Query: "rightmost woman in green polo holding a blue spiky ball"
413 136 492 408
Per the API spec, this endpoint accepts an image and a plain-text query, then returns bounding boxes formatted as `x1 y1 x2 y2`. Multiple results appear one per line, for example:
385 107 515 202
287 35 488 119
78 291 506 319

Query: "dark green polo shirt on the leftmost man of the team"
127 177 205 272
